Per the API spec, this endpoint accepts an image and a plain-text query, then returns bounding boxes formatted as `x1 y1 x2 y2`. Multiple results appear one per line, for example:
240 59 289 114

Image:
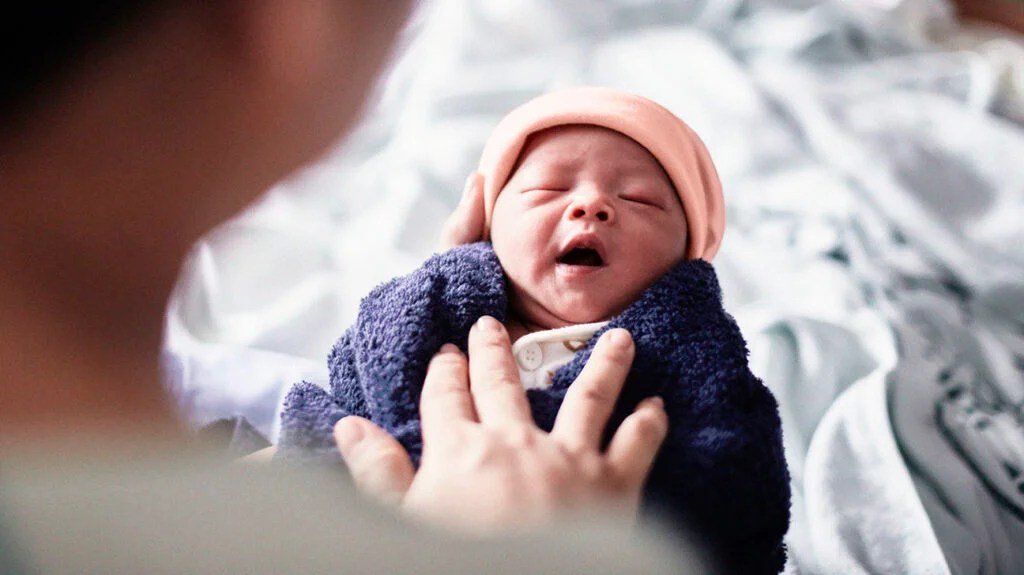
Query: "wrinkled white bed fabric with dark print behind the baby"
165 0 1024 573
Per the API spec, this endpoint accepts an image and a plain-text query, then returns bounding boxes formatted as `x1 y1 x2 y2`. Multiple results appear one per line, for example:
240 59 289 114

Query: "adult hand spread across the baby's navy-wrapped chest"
335 317 668 533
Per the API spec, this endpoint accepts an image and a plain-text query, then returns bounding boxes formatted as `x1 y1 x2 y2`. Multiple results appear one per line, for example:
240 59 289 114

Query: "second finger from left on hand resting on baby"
420 344 476 441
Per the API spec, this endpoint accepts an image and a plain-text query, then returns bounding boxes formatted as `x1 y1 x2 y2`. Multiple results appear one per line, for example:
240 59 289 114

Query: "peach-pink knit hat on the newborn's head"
478 87 725 261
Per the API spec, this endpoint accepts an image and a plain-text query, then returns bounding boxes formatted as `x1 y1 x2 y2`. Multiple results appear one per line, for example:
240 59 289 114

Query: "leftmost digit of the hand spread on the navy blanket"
334 415 414 505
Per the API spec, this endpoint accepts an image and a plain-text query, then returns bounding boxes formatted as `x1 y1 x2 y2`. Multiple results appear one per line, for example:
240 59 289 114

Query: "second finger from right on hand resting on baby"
551 328 635 450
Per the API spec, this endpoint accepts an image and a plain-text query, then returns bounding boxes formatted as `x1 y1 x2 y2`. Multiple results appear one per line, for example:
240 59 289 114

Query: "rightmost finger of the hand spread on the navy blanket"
606 397 669 494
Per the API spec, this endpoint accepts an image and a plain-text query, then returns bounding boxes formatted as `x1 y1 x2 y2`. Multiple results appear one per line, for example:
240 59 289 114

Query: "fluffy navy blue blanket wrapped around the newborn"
280 242 790 574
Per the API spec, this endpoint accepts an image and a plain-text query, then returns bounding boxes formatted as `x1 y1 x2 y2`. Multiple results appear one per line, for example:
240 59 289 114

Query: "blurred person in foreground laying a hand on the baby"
0 0 702 573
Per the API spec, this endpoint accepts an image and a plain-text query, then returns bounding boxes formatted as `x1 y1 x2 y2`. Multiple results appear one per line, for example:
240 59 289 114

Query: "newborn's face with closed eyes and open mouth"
490 126 686 328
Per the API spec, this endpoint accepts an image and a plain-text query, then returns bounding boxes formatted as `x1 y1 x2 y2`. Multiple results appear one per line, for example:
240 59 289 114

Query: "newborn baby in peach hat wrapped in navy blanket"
279 88 790 573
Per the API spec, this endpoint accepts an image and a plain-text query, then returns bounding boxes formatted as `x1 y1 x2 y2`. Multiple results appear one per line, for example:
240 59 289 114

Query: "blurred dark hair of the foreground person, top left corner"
0 0 161 119
